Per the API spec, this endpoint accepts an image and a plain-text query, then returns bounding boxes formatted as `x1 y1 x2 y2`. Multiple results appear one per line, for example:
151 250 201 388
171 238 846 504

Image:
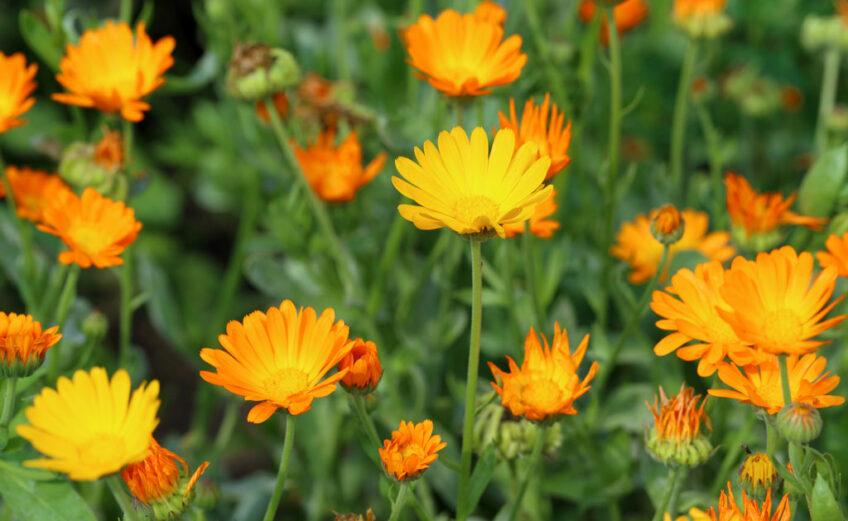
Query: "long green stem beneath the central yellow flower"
456 240 483 521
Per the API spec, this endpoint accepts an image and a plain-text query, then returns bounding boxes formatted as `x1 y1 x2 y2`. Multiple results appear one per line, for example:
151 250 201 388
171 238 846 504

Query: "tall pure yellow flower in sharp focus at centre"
392 127 553 238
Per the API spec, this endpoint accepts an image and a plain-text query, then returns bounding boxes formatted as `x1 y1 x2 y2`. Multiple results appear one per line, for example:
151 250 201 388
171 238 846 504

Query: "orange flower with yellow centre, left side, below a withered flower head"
38 188 141 268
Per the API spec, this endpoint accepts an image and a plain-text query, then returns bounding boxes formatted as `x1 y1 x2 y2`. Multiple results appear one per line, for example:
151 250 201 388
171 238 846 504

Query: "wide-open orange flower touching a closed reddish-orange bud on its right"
200 300 353 423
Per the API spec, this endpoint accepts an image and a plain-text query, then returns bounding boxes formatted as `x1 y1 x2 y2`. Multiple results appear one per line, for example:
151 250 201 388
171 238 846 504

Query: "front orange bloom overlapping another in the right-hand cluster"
718 246 846 355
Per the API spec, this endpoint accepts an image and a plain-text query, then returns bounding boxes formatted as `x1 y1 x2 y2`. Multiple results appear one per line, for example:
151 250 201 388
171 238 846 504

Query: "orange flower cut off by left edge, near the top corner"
0 52 38 134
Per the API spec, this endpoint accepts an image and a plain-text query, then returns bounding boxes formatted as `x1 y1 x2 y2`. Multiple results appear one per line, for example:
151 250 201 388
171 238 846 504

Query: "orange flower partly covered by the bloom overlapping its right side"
651 261 763 376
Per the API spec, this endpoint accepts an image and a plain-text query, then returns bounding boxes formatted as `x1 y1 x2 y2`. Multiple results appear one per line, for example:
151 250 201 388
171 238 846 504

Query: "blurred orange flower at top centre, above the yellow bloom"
403 9 527 97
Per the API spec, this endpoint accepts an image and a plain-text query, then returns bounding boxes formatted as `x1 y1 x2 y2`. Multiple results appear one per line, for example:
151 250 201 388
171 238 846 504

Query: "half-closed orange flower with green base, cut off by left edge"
0 311 62 378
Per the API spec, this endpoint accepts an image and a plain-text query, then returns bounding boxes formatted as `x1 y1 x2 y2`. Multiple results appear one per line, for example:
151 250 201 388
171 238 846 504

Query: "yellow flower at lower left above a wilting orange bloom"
17 367 159 481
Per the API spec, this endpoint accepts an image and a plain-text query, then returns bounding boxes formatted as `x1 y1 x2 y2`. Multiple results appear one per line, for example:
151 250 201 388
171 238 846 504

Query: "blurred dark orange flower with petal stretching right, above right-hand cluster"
724 172 827 237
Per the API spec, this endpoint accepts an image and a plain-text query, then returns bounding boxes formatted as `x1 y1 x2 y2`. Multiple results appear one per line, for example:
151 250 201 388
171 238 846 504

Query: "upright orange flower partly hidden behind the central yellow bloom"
498 94 571 181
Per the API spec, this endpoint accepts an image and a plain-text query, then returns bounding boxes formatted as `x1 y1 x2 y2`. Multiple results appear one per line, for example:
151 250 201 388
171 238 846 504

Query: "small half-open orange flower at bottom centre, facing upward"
378 420 447 481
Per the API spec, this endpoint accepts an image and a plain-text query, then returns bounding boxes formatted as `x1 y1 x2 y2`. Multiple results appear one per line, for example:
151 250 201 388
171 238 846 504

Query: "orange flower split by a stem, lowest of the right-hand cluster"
710 353 845 414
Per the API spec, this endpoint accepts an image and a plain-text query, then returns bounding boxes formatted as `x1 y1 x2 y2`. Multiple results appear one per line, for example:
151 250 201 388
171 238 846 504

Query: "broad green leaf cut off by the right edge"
798 145 848 217
